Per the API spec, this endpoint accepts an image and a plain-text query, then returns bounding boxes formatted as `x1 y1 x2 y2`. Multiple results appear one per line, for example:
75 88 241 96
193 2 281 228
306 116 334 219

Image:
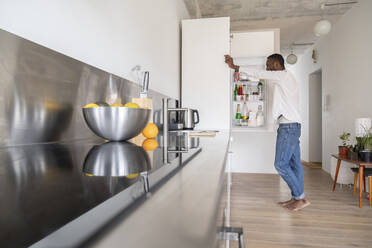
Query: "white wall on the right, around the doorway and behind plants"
291 0 372 172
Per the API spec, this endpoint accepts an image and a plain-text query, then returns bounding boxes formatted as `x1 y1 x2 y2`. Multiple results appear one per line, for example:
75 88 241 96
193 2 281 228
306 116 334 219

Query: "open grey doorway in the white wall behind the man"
309 70 322 166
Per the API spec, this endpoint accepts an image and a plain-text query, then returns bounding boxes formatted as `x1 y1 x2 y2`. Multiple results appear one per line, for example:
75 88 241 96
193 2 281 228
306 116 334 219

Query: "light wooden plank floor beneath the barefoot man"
231 167 372 248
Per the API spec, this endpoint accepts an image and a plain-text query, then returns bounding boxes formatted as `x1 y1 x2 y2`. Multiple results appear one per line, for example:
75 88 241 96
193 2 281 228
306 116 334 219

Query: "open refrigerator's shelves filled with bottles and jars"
230 72 268 130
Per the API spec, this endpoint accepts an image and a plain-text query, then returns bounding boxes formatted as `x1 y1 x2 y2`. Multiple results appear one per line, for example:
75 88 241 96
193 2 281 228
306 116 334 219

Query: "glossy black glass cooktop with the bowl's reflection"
0 135 198 247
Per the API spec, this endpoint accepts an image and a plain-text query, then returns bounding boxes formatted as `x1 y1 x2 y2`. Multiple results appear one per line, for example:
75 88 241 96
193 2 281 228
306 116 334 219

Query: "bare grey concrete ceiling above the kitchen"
184 0 353 54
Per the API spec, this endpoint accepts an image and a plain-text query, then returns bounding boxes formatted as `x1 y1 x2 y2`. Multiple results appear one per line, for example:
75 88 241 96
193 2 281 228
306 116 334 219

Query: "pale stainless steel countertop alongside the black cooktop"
89 132 229 248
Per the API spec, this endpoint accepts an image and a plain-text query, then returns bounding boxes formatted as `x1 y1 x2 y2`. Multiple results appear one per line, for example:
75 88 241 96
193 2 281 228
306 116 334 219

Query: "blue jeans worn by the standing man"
275 123 305 200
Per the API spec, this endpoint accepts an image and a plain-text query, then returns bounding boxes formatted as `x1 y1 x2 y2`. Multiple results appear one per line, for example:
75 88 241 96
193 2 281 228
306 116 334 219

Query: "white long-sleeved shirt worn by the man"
239 66 301 123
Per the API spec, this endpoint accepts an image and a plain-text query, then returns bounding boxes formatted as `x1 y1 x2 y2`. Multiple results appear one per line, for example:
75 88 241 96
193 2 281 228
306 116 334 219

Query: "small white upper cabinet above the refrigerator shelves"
231 29 280 58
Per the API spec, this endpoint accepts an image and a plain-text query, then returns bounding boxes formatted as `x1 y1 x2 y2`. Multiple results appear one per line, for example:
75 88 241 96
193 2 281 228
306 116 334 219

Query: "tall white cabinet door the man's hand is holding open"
181 17 230 129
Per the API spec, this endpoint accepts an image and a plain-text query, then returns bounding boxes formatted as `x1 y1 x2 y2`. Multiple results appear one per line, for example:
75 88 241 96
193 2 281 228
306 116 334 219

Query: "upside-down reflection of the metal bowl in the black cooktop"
83 142 151 177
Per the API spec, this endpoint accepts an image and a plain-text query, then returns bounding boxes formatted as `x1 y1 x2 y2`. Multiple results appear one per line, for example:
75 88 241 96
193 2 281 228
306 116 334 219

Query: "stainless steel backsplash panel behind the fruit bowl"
0 29 176 147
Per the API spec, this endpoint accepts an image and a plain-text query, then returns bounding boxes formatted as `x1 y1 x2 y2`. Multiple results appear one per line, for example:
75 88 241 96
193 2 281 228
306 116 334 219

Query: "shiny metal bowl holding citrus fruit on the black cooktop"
83 107 151 141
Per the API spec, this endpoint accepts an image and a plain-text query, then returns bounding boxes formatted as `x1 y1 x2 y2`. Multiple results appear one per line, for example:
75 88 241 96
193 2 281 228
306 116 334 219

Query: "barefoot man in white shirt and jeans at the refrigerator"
225 54 310 211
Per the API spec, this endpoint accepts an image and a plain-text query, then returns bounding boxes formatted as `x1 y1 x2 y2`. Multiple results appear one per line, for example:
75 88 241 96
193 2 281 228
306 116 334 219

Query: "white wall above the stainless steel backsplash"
0 0 189 98
